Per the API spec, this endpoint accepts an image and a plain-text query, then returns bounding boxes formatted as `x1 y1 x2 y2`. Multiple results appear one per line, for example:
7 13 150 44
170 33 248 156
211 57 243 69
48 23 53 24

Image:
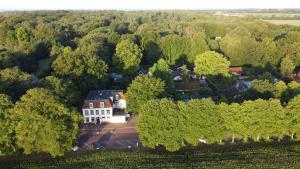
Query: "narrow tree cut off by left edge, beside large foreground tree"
0 94 16 156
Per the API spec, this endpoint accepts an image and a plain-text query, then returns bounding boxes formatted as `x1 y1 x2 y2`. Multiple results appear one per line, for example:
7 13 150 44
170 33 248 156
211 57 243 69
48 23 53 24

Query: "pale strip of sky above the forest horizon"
0 0 300 10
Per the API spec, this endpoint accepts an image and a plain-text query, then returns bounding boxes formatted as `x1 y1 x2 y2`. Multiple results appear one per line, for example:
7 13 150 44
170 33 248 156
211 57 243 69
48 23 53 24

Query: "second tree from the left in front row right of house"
183 99 224 145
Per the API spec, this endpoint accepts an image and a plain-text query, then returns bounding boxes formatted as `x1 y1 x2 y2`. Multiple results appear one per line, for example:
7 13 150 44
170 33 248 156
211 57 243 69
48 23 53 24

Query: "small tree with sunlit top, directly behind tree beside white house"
149 59 174 94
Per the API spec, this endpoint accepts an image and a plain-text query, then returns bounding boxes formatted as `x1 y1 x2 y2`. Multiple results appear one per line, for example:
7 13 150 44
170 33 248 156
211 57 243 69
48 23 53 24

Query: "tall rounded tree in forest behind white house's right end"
113 39 142 75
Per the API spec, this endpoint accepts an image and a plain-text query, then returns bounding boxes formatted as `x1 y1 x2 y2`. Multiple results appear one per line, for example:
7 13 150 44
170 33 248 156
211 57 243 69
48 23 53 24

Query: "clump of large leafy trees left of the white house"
0 88 82 156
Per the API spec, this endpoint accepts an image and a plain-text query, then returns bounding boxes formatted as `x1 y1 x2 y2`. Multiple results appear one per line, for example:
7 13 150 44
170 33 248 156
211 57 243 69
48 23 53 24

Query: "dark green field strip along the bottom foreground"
0 142 300 169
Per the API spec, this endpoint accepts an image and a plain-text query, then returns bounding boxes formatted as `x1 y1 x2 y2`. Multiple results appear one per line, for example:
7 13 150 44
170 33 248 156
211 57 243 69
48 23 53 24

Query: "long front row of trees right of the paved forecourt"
137 95 300 151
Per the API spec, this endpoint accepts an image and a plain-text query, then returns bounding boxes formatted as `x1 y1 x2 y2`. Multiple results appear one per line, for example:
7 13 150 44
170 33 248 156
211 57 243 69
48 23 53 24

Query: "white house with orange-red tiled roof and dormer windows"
82 90 126 123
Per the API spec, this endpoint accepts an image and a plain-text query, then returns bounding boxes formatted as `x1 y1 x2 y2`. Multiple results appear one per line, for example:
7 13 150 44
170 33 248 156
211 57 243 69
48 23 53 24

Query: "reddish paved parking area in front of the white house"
78 117 141 150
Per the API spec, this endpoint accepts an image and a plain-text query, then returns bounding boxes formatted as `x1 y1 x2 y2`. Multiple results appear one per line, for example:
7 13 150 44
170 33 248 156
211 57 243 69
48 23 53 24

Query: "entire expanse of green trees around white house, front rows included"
0 11 300 156
